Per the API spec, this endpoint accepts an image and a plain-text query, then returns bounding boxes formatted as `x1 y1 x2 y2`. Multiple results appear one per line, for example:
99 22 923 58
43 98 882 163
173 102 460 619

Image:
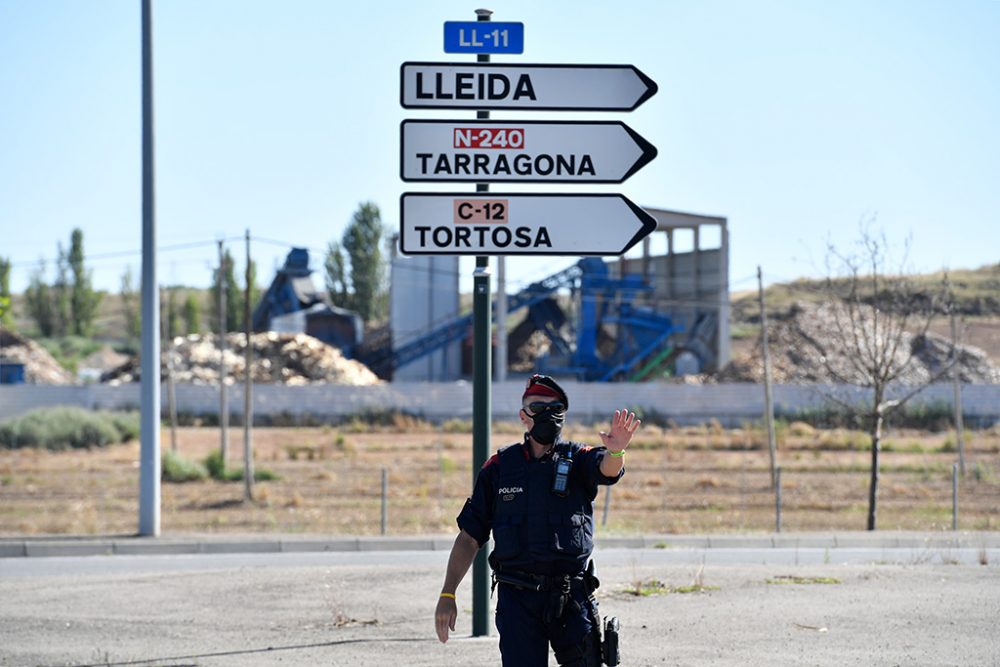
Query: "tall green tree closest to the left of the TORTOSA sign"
343 202 386 321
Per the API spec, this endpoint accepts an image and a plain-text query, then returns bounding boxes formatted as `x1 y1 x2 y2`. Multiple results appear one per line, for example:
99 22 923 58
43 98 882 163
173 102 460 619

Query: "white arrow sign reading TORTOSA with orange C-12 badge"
399 192 656 255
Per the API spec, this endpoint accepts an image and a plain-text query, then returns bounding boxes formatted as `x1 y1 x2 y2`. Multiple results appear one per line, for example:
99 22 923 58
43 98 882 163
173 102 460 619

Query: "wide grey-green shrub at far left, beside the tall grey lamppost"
0 407 139 450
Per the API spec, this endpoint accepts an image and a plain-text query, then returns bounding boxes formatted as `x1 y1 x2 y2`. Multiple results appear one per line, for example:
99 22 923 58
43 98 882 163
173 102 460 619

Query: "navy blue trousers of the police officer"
496 583 593 667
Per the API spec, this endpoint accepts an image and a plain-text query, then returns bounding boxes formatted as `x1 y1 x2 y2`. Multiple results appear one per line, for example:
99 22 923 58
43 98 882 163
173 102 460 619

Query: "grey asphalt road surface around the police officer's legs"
0 548 1000 667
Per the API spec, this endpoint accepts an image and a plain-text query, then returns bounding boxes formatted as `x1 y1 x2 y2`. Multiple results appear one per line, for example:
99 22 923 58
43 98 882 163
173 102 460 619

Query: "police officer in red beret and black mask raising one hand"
435 375 640 667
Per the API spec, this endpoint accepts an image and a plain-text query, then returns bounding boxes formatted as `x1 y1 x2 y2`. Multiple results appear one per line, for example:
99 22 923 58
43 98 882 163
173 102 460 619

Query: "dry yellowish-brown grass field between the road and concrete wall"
0 418 1000 536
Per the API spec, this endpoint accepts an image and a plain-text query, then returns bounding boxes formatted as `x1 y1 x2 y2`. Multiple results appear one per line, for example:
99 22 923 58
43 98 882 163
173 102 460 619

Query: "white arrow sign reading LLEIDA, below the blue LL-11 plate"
399 62 657 111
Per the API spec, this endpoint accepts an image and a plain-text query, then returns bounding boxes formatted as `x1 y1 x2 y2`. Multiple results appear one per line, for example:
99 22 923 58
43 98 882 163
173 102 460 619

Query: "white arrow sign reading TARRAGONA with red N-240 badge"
399 120 656 183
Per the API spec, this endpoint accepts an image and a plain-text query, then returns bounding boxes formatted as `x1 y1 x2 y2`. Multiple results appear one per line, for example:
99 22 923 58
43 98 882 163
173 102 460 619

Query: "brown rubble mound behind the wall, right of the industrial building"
716 305 1000 385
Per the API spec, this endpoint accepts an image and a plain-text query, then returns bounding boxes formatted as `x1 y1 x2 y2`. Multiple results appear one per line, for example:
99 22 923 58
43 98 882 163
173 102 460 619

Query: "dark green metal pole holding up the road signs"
472 9 493 637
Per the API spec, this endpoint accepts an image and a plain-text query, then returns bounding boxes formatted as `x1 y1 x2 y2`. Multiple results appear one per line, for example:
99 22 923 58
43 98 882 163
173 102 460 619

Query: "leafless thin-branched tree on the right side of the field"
824 226 951 530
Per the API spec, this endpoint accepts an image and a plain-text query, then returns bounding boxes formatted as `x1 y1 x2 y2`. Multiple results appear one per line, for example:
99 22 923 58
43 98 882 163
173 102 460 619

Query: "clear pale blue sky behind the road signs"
0 0 1000 298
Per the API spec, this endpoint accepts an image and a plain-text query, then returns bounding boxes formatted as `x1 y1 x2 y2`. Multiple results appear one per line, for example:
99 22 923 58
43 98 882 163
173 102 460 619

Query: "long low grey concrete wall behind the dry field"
0 381 1000 426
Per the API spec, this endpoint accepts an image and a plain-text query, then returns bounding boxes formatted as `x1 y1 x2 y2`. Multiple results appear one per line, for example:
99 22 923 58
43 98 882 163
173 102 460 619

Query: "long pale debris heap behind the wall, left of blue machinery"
101 332 381 386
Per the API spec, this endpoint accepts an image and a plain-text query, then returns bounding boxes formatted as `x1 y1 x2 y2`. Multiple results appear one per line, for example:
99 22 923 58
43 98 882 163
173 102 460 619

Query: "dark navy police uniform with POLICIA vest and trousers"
458 435 624 667
